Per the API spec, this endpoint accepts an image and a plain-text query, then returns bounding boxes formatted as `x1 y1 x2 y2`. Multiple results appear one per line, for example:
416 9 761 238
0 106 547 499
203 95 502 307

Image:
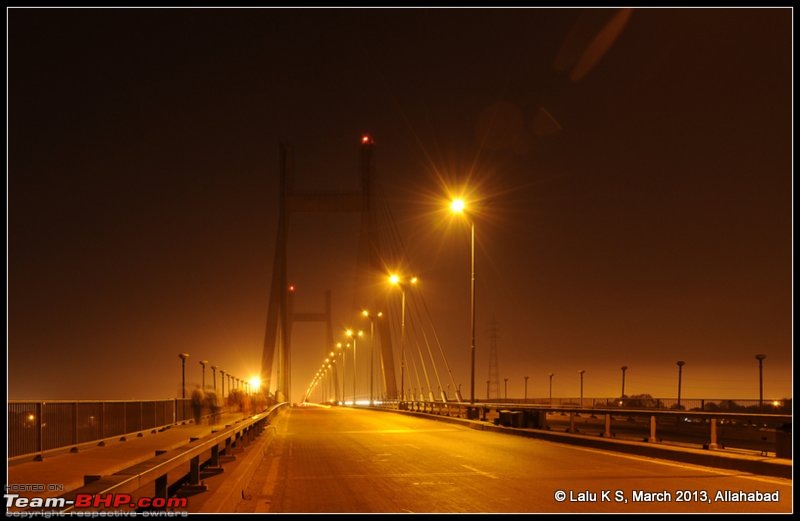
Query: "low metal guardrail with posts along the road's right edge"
372 402 792 458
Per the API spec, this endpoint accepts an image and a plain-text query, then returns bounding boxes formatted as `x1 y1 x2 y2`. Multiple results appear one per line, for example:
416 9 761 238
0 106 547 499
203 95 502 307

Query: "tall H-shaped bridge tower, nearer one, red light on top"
261 135 397 401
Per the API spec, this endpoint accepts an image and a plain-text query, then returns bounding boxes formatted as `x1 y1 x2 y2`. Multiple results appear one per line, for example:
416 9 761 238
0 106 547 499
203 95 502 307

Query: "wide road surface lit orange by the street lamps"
235 406 792 513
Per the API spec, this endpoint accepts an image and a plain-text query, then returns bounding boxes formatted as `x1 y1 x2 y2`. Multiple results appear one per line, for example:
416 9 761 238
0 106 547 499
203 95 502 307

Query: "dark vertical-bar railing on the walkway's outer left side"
7 399 193 458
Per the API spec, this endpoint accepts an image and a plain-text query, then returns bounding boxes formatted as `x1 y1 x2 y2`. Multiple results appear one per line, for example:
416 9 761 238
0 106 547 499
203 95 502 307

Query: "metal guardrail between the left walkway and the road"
59 402 289 512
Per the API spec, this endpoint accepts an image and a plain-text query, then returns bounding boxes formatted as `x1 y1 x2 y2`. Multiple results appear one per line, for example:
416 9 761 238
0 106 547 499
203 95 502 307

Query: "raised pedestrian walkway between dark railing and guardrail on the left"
6 412 245 497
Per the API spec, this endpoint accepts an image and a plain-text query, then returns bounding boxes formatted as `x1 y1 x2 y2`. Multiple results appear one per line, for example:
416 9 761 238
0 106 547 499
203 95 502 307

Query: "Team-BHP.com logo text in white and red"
4 494 188 509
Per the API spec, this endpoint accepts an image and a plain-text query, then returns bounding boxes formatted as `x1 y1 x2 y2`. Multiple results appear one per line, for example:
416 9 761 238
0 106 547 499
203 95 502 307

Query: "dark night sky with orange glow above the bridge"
7 8 792 400
